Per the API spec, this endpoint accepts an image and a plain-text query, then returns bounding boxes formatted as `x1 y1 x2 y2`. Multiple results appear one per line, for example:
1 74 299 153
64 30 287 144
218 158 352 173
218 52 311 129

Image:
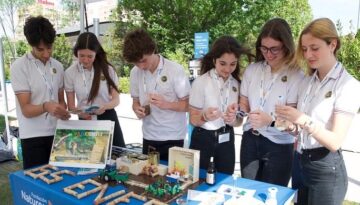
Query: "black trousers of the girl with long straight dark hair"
97 109 125 147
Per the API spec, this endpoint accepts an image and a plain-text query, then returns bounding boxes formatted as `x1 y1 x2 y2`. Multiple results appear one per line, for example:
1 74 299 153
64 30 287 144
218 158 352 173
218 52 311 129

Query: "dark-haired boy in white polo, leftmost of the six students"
10 16 70 169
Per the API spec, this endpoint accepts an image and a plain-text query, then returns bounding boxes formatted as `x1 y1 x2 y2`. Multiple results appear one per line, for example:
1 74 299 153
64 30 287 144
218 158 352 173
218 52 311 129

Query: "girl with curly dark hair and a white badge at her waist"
189 36 250 174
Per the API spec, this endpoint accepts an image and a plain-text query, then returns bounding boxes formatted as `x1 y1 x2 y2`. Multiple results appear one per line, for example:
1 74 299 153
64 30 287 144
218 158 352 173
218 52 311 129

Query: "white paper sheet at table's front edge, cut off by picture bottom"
187 189 225 205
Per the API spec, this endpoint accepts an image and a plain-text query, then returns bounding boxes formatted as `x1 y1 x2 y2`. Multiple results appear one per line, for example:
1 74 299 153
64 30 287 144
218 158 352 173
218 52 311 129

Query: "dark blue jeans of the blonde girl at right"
298 147 348 205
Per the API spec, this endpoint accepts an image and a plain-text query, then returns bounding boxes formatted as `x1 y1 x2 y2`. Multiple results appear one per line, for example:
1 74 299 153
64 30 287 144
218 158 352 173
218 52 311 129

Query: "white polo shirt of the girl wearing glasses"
240 61 304 144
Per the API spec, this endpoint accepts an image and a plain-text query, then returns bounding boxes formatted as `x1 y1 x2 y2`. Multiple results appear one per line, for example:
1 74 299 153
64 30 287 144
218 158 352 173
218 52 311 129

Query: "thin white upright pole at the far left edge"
0 38 12 150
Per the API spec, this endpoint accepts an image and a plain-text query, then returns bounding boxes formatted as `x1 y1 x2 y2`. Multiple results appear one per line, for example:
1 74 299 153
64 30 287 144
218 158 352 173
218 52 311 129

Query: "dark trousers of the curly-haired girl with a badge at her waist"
190 126 235 174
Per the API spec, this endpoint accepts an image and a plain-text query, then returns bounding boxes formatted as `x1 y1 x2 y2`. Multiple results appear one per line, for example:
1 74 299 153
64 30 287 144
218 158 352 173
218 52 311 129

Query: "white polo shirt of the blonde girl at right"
298 62 360 150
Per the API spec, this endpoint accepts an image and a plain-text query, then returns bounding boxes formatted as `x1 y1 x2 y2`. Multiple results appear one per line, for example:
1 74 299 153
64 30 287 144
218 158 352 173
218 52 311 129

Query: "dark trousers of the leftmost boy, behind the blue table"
21 136 54 169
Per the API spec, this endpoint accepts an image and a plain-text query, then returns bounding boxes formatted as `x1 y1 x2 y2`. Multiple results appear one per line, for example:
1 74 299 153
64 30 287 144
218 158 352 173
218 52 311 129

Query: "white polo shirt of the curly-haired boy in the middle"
130 55 190 141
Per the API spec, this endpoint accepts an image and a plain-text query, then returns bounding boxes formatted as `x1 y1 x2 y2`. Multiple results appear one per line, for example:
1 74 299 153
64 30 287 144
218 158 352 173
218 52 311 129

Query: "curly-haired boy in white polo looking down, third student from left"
123 29 190 160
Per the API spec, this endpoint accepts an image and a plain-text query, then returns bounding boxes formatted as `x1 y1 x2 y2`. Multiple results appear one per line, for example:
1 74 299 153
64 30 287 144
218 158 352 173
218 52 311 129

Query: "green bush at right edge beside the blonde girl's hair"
338 32 360 80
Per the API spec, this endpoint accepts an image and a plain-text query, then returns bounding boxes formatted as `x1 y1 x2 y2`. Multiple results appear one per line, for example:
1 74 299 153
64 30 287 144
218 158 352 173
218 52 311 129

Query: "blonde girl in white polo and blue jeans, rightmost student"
276 18 360 204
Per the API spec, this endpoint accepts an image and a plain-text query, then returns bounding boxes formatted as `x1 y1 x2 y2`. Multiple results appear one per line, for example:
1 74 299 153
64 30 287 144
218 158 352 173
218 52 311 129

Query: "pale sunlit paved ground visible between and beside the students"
0 84 360 202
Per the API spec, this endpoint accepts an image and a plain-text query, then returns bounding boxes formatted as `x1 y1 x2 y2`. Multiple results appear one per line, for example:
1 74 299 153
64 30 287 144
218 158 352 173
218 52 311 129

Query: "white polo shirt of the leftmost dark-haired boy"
10 53 64 139
